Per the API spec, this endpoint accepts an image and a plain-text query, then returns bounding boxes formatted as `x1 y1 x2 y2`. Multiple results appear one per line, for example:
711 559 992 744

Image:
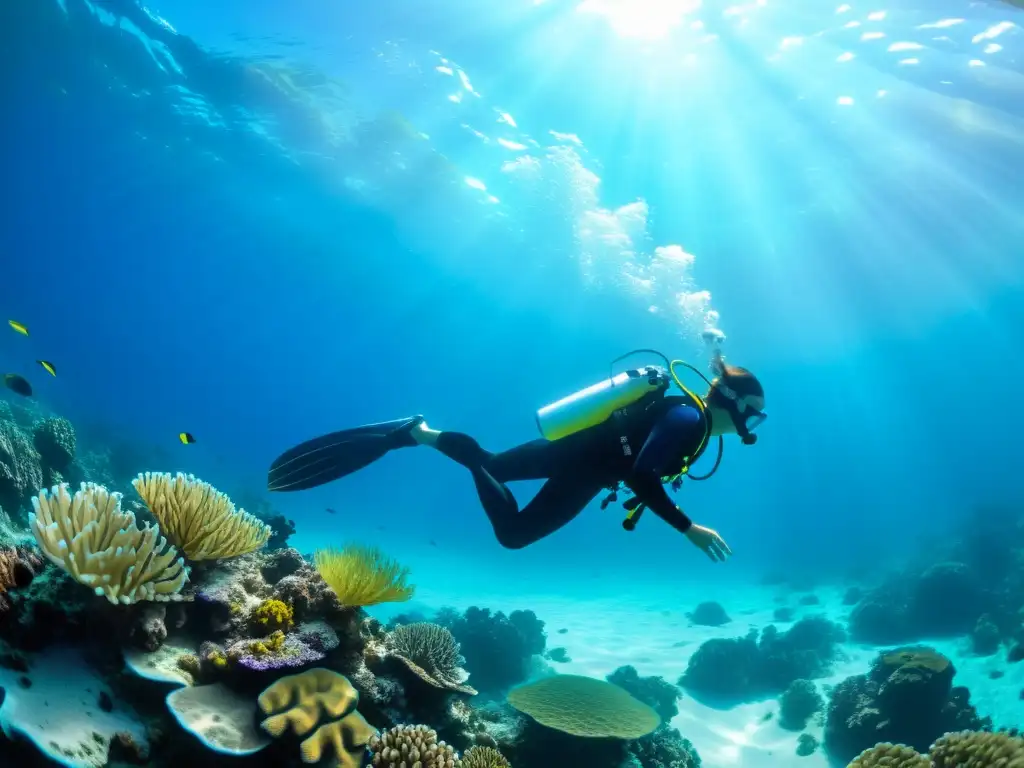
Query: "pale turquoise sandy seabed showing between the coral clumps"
382 569 1024 768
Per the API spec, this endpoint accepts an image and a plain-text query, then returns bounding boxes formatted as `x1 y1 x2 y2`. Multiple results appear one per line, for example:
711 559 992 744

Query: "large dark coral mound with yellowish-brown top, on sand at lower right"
824 646 991 760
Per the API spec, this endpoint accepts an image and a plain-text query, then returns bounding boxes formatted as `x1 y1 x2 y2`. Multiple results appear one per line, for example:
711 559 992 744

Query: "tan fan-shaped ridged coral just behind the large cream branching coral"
132 472 270 560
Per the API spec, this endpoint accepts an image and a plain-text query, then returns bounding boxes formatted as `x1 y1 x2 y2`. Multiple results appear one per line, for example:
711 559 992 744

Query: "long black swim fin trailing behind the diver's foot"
266 416 423 490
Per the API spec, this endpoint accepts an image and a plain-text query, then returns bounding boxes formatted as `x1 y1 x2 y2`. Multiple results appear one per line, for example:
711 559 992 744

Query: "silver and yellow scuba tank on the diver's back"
537 366 672 440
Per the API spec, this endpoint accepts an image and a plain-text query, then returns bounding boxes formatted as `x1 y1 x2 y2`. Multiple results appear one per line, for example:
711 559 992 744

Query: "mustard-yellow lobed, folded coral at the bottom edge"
258 668 376 768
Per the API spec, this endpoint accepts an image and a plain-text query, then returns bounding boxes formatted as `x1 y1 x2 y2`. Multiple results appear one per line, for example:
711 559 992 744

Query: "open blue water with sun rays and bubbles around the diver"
0 0 1024 597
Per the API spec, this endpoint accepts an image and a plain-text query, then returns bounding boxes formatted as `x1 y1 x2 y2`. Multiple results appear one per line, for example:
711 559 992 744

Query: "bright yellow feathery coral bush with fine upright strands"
313 545 416 607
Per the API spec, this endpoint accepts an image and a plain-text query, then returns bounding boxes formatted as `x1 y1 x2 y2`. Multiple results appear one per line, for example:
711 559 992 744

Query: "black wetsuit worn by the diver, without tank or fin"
436 393 710 549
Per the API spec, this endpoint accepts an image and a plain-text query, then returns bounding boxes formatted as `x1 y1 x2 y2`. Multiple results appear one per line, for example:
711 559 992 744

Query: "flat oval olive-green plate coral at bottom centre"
508 675 662 739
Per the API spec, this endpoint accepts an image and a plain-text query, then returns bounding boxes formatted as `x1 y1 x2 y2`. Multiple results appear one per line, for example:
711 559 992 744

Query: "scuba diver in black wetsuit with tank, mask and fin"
267 349 766 562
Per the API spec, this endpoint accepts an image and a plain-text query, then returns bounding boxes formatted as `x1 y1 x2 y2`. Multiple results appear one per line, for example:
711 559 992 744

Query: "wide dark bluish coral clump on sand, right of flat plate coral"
679 616 843 699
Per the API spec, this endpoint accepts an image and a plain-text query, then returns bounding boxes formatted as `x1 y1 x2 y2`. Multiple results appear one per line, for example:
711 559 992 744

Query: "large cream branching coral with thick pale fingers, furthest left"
29 483 188 604
